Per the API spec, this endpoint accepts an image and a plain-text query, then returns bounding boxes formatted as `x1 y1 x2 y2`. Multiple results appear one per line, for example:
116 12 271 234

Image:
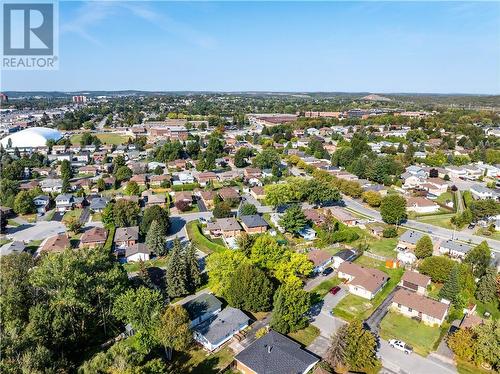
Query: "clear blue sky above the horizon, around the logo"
2 1 500 94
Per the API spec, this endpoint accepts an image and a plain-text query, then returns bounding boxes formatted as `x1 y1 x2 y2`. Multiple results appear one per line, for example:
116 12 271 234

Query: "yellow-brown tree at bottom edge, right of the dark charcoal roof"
326 320 380 372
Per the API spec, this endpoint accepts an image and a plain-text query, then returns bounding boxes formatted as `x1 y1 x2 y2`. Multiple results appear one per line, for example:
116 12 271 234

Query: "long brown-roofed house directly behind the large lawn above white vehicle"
391 288 449 326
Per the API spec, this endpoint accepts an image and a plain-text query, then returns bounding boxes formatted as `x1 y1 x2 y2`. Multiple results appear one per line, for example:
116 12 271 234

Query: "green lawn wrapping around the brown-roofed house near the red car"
333 256 404 322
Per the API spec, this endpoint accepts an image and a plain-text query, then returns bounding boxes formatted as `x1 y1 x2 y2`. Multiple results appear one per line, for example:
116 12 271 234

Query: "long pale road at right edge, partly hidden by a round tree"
343 196 500 252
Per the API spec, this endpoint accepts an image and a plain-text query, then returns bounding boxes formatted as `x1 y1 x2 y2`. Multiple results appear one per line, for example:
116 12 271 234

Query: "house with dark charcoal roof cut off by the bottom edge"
234 330 319 374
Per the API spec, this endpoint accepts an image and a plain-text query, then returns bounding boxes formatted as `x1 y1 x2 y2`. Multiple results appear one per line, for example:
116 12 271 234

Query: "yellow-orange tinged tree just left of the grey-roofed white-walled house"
156 305 193 360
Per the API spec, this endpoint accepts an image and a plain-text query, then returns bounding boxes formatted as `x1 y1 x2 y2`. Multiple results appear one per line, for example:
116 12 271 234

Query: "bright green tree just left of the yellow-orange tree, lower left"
113 287 163 353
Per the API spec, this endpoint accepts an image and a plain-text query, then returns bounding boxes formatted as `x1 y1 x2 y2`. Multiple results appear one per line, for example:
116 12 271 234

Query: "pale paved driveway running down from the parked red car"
307 288 347 357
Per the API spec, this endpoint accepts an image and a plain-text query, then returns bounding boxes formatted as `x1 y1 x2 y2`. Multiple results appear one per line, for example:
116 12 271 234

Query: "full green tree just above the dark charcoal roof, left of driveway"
270 284 311 334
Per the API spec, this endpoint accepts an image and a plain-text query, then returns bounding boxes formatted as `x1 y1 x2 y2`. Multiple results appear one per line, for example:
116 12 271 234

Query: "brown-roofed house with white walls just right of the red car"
338 262 389 300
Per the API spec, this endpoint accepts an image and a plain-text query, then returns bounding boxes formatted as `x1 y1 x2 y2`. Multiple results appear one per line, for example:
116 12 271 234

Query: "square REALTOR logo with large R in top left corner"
2 0 57 70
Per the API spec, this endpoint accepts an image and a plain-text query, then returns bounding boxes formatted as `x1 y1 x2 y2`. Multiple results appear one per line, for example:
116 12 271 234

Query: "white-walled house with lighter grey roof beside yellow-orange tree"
193 306 250 351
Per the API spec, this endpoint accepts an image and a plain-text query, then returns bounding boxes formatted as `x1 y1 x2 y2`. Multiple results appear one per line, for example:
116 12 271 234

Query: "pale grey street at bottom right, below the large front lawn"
379 339 457 374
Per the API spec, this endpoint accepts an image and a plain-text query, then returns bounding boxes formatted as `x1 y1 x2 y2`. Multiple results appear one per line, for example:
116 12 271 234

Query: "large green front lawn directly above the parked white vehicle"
380 312 441 356
